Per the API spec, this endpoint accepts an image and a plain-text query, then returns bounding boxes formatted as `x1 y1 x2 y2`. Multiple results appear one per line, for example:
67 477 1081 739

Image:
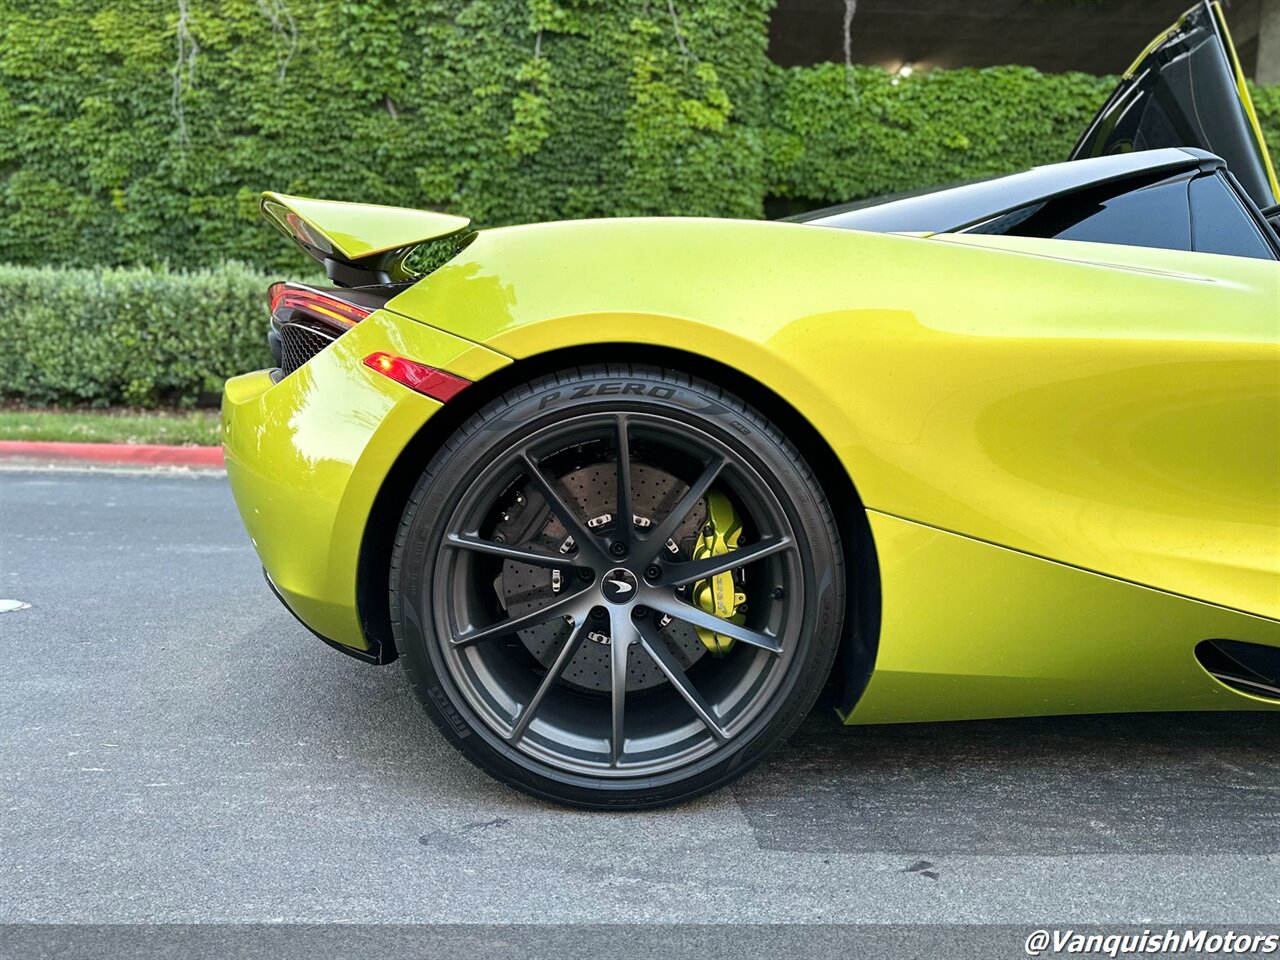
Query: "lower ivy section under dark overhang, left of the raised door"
765 64 1116 212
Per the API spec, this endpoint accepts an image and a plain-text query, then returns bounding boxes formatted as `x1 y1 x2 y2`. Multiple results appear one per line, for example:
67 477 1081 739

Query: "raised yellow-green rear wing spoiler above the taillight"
261 193 471 287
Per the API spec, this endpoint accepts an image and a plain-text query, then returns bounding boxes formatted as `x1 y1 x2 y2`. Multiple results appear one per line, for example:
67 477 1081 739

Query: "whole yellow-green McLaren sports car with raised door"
223 4 1280 808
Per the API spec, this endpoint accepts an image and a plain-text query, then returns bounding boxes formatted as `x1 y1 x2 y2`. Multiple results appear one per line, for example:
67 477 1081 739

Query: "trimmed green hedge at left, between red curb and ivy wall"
0 264 273 407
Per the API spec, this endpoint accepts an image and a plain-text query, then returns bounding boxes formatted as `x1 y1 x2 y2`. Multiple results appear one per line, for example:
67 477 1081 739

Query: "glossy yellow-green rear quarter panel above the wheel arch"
389 219 1280 618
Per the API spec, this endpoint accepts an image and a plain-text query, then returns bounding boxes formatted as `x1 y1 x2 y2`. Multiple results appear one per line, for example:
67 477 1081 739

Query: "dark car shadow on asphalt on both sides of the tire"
269 632 1280 855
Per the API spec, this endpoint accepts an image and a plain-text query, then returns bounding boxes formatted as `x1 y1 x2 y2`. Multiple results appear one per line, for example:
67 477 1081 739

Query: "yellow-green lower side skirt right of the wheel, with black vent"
844 511 1280 723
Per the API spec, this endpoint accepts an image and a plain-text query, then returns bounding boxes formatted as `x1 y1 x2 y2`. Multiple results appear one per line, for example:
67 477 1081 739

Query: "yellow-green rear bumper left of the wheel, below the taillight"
223 310 509 660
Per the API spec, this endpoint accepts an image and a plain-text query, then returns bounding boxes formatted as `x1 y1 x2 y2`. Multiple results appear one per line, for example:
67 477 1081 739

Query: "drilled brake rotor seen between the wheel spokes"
494 462 707 692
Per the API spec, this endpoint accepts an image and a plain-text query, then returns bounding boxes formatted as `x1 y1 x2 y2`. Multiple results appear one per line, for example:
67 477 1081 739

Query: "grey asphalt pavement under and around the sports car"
0 470 1280 924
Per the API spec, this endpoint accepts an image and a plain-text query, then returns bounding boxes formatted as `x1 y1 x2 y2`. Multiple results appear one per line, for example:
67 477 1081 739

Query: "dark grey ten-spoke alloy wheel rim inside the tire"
435 411 805 777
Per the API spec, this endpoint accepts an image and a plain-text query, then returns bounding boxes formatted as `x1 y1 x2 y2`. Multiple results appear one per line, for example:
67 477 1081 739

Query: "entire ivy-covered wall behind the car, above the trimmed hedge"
0 0 1280 269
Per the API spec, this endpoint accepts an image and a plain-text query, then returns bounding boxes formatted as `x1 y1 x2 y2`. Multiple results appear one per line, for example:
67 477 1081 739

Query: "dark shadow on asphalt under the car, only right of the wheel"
735 709 1280 855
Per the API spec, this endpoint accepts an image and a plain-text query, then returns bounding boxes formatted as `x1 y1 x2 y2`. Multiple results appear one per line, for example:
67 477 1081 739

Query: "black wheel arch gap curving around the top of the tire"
356 343 881 713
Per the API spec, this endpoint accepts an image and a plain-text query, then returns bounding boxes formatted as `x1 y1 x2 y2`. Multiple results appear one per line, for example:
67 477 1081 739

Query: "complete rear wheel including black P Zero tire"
390 365 846 809
